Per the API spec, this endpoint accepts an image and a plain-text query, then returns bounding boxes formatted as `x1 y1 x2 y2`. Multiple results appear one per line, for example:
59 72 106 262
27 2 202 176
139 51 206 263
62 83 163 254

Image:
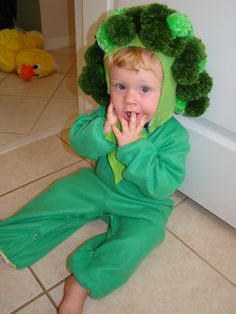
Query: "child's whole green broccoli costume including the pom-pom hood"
0 4 212 298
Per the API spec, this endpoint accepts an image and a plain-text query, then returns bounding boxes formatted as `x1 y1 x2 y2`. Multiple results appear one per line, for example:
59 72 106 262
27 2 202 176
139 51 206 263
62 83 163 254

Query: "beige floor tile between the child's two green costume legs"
32 221 106 289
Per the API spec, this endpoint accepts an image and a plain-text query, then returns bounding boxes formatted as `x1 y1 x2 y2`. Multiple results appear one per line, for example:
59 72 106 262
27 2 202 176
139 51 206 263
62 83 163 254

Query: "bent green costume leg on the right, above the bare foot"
68 216 165 299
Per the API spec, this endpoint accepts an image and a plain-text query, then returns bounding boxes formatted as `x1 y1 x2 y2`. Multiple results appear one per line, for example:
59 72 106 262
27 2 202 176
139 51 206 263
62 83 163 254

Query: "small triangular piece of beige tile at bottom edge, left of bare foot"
17 296 56 314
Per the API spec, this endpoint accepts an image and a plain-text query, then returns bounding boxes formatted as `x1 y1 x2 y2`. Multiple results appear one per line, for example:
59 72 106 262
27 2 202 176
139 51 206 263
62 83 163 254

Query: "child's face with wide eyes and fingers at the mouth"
110 65 162 122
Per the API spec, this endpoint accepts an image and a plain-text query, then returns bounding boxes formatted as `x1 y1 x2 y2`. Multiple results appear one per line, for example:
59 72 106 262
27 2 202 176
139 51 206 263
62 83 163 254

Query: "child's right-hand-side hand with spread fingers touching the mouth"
111 112 147 146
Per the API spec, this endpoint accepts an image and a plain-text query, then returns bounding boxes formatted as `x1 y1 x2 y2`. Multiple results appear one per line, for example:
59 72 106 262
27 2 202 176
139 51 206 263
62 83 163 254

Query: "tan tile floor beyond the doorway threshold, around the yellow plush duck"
0 46 78 154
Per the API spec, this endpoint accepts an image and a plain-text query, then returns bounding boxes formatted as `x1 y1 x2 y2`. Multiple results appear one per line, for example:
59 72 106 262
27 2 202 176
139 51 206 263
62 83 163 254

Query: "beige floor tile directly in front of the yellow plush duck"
0 73 64 97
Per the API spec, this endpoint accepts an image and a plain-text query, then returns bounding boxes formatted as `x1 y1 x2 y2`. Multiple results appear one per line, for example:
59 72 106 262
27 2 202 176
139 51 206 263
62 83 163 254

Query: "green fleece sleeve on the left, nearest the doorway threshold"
69 107 115 160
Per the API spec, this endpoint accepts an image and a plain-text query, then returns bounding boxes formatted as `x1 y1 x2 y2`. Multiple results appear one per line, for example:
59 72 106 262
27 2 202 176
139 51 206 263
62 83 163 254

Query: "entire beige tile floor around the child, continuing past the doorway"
0 50 236 314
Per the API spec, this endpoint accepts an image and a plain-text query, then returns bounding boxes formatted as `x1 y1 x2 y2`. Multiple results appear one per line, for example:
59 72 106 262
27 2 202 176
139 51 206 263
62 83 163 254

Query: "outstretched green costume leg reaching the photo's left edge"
0 169 106 268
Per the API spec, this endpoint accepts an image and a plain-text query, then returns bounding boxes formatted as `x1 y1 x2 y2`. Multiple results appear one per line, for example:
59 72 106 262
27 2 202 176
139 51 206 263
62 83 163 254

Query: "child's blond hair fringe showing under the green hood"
104 47 163 78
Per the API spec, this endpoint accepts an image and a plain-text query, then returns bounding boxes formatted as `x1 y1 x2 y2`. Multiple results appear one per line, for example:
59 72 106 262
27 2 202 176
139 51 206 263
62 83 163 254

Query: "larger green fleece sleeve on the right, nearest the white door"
116 120 189 199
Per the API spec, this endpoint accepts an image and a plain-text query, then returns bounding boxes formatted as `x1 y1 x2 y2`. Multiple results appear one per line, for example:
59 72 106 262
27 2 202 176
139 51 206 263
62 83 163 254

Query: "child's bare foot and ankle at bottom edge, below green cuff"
57 275 88 314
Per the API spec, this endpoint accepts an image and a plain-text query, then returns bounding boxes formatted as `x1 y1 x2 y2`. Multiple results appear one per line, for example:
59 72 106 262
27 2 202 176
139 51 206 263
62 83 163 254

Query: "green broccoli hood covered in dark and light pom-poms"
78 3 212 132
